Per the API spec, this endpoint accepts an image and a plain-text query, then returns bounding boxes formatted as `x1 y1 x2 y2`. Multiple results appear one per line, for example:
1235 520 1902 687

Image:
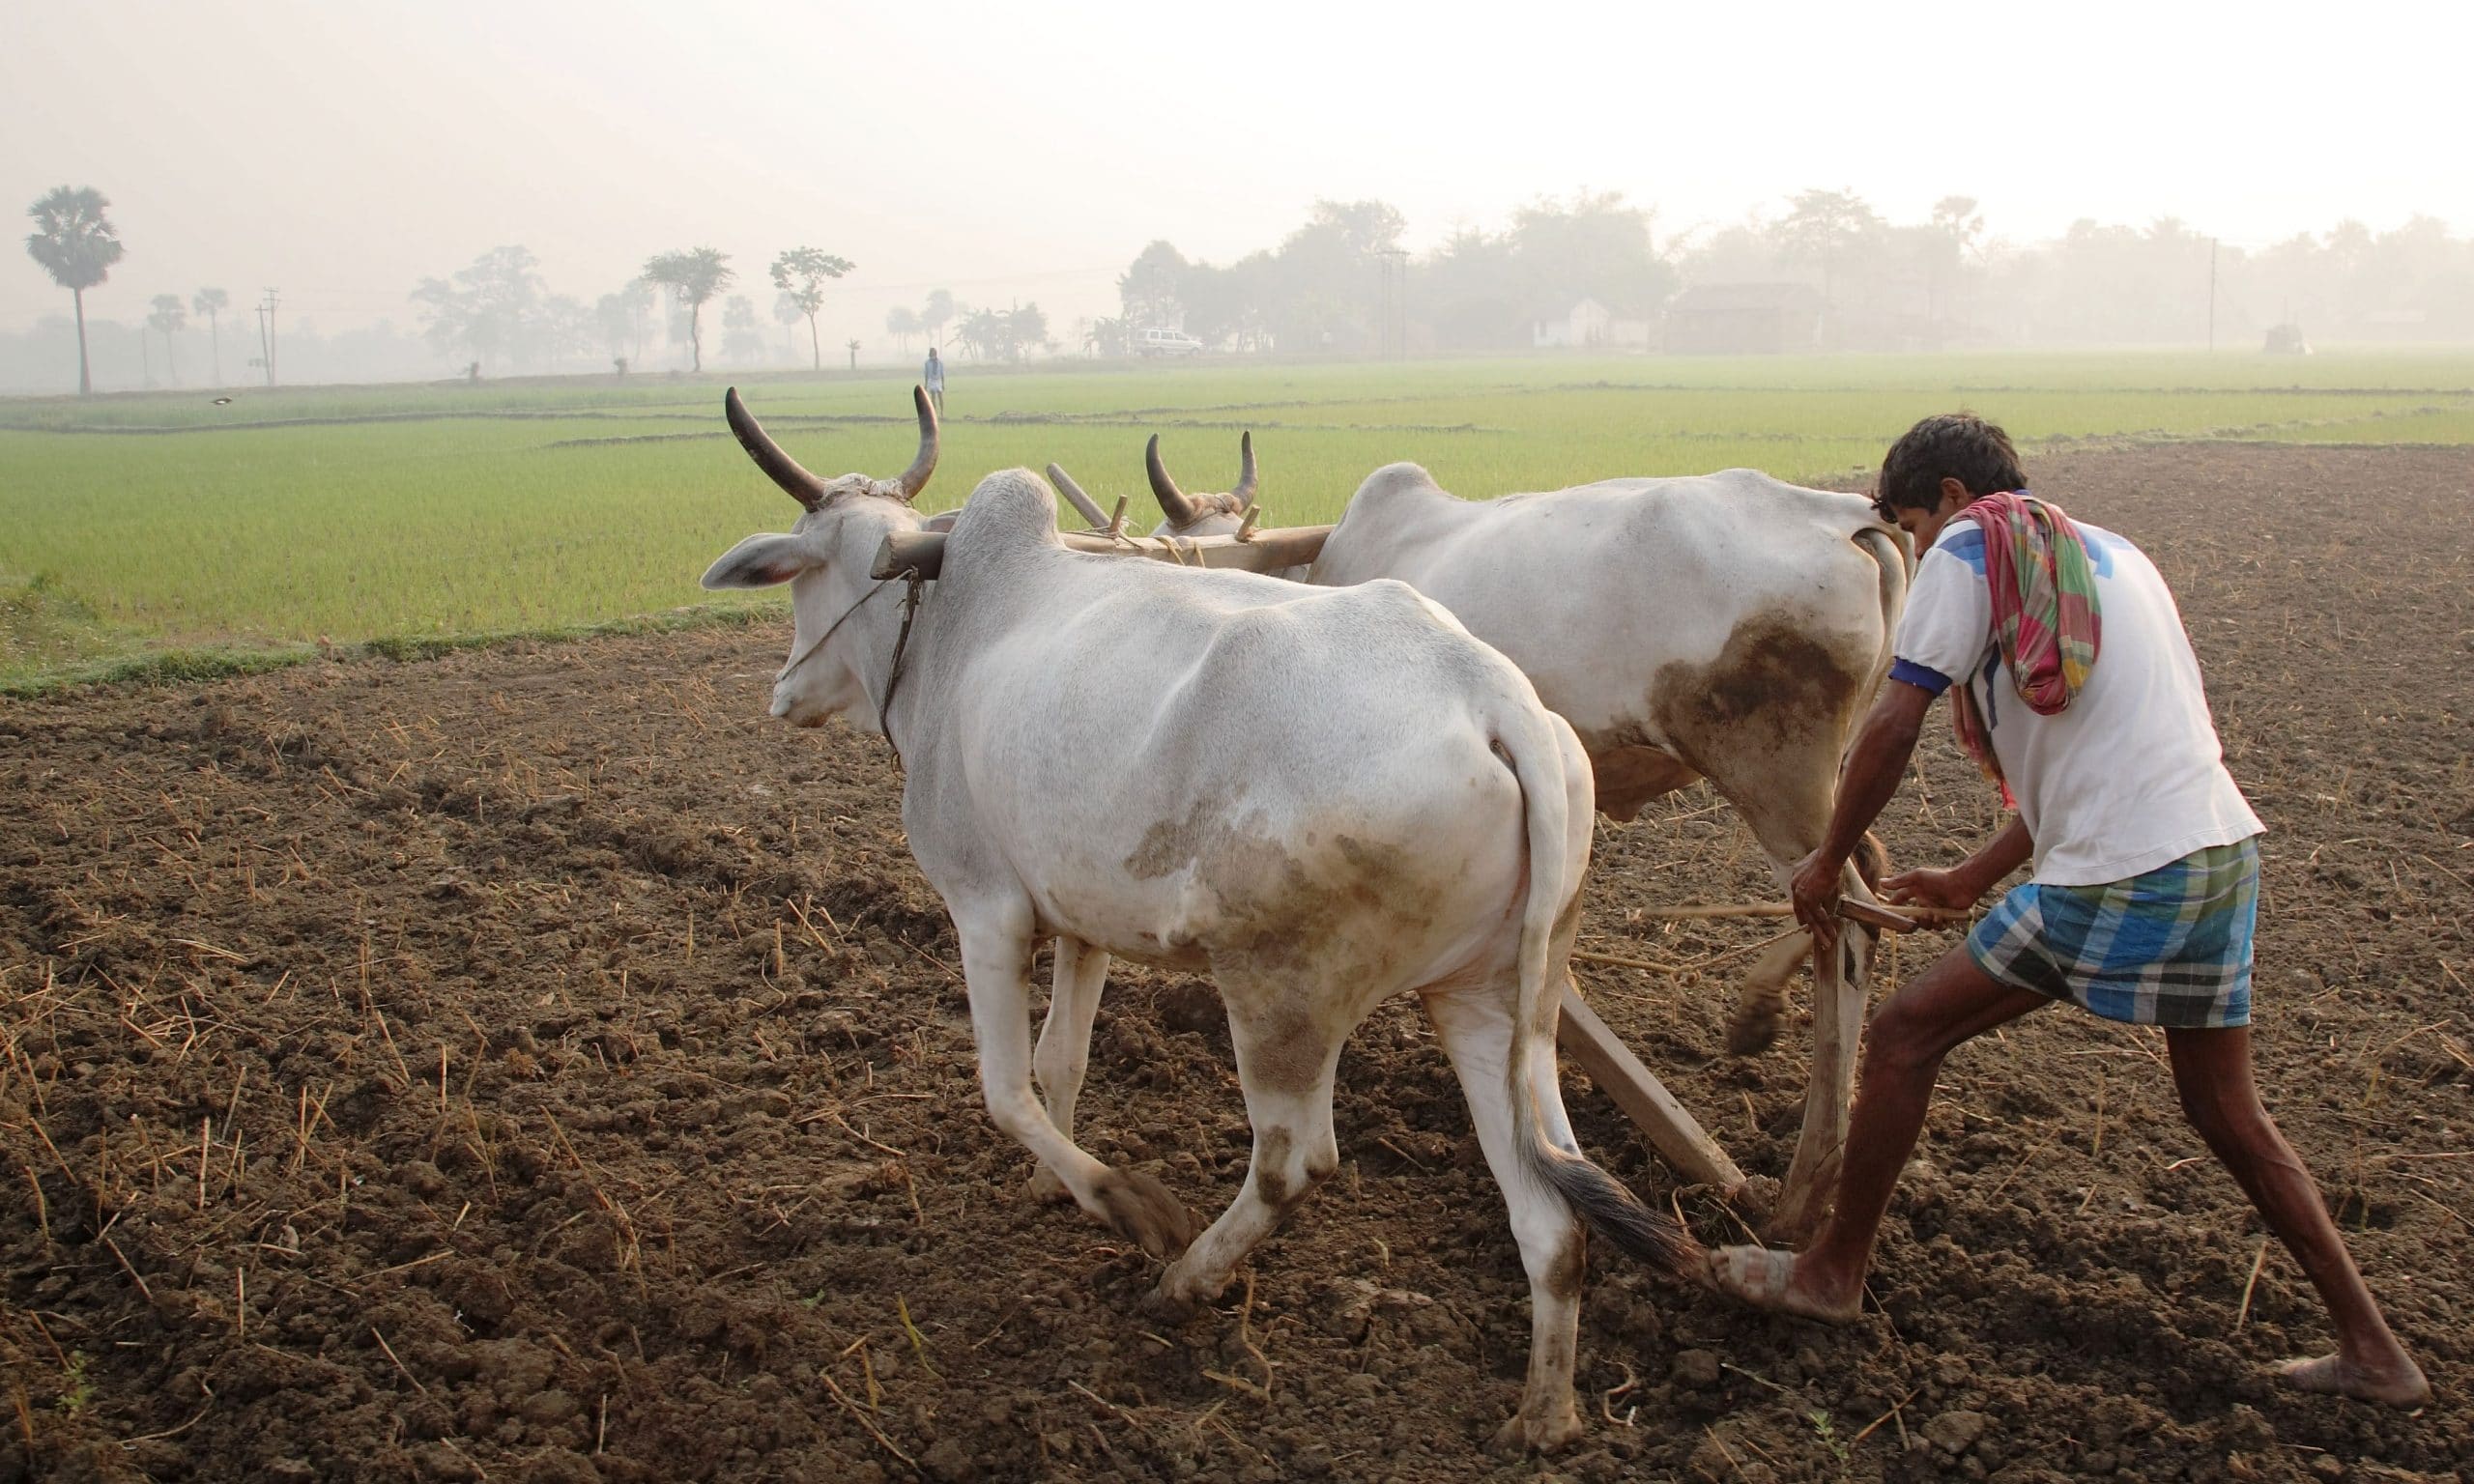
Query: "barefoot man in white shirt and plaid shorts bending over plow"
1712 414 2430 1408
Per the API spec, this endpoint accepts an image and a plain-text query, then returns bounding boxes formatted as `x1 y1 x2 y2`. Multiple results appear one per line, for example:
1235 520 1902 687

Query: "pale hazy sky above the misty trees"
0 0 2474 341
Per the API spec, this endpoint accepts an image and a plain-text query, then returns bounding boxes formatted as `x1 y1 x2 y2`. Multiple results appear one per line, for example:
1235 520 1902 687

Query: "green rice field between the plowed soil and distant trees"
0 352 2474 690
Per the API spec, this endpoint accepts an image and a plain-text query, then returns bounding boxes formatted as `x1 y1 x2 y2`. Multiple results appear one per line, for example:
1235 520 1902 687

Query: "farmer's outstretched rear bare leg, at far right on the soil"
2165 1026 2431 1408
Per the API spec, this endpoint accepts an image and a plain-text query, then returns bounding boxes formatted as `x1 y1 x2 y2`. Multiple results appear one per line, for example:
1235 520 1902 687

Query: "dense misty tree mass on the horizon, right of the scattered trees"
1118 190 2474 357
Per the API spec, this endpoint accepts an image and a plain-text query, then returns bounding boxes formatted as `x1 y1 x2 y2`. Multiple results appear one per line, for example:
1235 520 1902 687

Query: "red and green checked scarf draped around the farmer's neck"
1952 490 2106 804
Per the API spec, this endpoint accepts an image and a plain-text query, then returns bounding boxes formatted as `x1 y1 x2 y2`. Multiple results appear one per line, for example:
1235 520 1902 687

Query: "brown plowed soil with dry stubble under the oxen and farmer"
14 445 2474 1484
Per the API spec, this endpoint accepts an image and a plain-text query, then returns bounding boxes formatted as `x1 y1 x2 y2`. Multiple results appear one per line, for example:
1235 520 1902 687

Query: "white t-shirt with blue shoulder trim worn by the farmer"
1890 520 2263 885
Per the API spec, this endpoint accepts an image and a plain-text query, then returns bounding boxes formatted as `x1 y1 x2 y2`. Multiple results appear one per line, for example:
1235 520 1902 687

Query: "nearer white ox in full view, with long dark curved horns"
703 393 1700 1447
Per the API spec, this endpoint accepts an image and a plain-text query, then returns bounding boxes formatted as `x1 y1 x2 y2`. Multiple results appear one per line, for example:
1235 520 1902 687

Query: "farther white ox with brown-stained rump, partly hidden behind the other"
1123 436 1908 1234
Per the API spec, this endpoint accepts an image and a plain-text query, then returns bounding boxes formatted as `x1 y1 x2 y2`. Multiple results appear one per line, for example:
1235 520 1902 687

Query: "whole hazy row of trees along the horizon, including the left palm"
19 186 2474 390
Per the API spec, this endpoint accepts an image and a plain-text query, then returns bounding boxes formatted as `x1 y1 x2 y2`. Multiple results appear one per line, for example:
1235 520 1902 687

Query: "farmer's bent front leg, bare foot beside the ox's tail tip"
1712 945 2051 1318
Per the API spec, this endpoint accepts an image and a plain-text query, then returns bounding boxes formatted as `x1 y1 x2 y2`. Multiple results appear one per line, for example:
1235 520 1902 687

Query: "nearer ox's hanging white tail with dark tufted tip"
1497 710 1702 1276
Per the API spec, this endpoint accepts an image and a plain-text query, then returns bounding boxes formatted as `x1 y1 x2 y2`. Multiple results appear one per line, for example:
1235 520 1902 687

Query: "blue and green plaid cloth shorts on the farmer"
1967 836 2258 1029
